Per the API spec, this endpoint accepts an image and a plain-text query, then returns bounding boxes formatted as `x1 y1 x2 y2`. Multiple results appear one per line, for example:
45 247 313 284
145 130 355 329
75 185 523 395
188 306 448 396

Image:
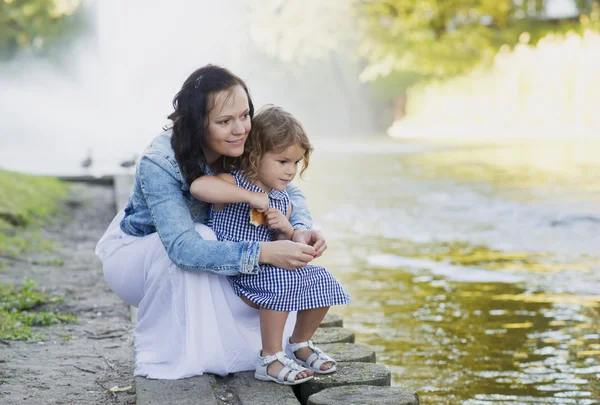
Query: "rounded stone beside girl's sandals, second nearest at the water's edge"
296 363 392 404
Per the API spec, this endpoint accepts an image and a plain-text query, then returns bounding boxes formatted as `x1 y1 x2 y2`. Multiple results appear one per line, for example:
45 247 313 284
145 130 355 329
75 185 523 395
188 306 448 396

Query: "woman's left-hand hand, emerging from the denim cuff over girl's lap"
258 240 315 270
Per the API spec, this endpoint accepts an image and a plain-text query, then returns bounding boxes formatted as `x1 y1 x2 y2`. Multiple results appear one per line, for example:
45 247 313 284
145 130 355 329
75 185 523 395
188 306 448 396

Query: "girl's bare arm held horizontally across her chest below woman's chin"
190 173 269 211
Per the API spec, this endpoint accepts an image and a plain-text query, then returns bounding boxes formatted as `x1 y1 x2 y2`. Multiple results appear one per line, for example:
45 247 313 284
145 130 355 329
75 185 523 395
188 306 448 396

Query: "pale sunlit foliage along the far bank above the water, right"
397 30 600 128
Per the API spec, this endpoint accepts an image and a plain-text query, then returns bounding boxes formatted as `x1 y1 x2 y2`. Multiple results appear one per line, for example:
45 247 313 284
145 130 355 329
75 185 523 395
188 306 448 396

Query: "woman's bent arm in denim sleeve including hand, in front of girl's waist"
138 154 314 275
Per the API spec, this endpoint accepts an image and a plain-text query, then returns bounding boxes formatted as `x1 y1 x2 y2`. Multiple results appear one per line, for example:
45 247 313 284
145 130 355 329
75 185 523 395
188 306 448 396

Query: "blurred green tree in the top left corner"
0 0 87 60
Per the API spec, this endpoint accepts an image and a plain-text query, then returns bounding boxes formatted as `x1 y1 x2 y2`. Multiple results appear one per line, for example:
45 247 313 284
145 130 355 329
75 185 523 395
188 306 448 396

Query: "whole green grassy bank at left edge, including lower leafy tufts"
0 170 75 341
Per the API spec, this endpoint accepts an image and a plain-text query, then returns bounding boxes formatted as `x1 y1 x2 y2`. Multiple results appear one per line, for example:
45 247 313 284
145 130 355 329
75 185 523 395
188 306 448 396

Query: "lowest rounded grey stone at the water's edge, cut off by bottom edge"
308 385 419 405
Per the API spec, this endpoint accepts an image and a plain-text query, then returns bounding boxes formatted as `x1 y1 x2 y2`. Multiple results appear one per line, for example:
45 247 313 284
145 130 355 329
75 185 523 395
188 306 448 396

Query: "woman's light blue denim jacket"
120 129 312 275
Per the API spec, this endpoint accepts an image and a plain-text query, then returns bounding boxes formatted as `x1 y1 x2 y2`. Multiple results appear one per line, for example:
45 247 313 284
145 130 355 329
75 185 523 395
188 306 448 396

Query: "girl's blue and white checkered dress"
208 171 350 312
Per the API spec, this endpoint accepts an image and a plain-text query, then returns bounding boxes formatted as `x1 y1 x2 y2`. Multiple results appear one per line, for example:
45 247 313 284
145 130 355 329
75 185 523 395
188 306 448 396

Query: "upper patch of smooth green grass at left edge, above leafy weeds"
0 170 68 256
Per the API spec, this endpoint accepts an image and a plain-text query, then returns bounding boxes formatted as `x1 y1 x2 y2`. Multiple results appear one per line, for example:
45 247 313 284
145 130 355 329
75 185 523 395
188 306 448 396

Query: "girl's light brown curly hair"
237 104 313 182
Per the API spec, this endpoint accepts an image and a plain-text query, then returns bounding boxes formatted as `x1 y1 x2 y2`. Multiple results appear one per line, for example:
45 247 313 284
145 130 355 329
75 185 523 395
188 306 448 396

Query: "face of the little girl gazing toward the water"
256 145 306 192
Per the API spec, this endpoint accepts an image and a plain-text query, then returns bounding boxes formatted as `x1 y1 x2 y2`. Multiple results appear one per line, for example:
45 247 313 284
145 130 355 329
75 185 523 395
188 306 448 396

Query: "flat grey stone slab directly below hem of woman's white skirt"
135 374 221 405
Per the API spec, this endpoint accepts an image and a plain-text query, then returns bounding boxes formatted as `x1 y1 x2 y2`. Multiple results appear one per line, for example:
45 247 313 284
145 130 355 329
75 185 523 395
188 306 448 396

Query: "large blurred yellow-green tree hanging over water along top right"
247 0 600 104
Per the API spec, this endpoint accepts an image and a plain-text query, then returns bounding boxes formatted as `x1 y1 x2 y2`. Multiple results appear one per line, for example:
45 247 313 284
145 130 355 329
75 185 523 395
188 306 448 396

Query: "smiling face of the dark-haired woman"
202 85 251 164
